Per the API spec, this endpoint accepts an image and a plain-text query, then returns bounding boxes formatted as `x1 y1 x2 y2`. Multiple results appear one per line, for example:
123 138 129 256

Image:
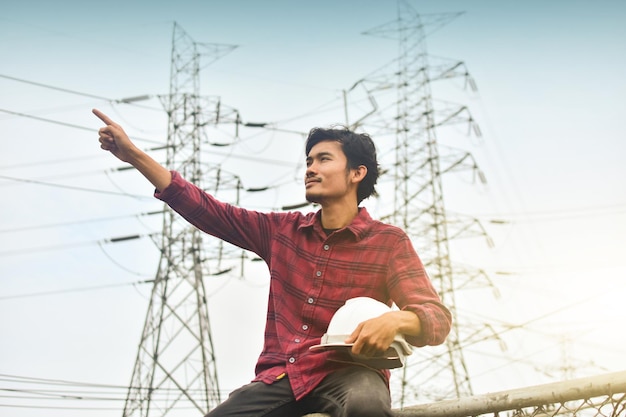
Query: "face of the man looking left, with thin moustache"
304 141 358 203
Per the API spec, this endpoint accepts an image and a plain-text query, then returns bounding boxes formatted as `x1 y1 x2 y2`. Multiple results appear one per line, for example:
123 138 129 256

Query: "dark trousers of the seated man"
206 366 392 417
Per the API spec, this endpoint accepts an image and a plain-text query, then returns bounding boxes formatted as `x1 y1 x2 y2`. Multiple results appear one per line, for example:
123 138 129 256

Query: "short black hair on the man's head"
305 126 380 204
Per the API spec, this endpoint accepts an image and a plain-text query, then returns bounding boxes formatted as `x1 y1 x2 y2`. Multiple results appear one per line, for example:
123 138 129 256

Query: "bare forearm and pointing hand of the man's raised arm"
92 109 172 191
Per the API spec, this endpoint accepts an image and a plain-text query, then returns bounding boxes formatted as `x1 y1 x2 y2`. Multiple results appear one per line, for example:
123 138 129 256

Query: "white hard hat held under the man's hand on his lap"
310 297 412 369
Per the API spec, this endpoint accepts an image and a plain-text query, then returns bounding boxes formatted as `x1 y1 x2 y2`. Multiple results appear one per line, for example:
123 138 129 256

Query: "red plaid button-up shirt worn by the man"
155 171 451 399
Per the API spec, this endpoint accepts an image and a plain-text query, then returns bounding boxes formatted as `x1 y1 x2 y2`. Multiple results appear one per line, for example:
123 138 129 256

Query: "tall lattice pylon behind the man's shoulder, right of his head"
346 0 493 406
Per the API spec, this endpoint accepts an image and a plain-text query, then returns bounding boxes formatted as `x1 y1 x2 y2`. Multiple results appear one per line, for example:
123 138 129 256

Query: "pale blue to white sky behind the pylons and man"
0 0 626 416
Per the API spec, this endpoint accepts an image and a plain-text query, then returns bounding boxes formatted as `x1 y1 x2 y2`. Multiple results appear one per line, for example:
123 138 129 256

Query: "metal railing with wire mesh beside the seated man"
395 371 626 417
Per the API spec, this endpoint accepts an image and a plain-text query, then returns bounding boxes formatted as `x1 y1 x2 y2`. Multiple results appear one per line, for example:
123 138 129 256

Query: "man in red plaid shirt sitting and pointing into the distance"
94 110 451 417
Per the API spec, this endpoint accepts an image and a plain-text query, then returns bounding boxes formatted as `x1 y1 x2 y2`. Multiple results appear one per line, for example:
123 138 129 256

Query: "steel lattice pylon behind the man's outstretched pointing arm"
123 24 239 417
